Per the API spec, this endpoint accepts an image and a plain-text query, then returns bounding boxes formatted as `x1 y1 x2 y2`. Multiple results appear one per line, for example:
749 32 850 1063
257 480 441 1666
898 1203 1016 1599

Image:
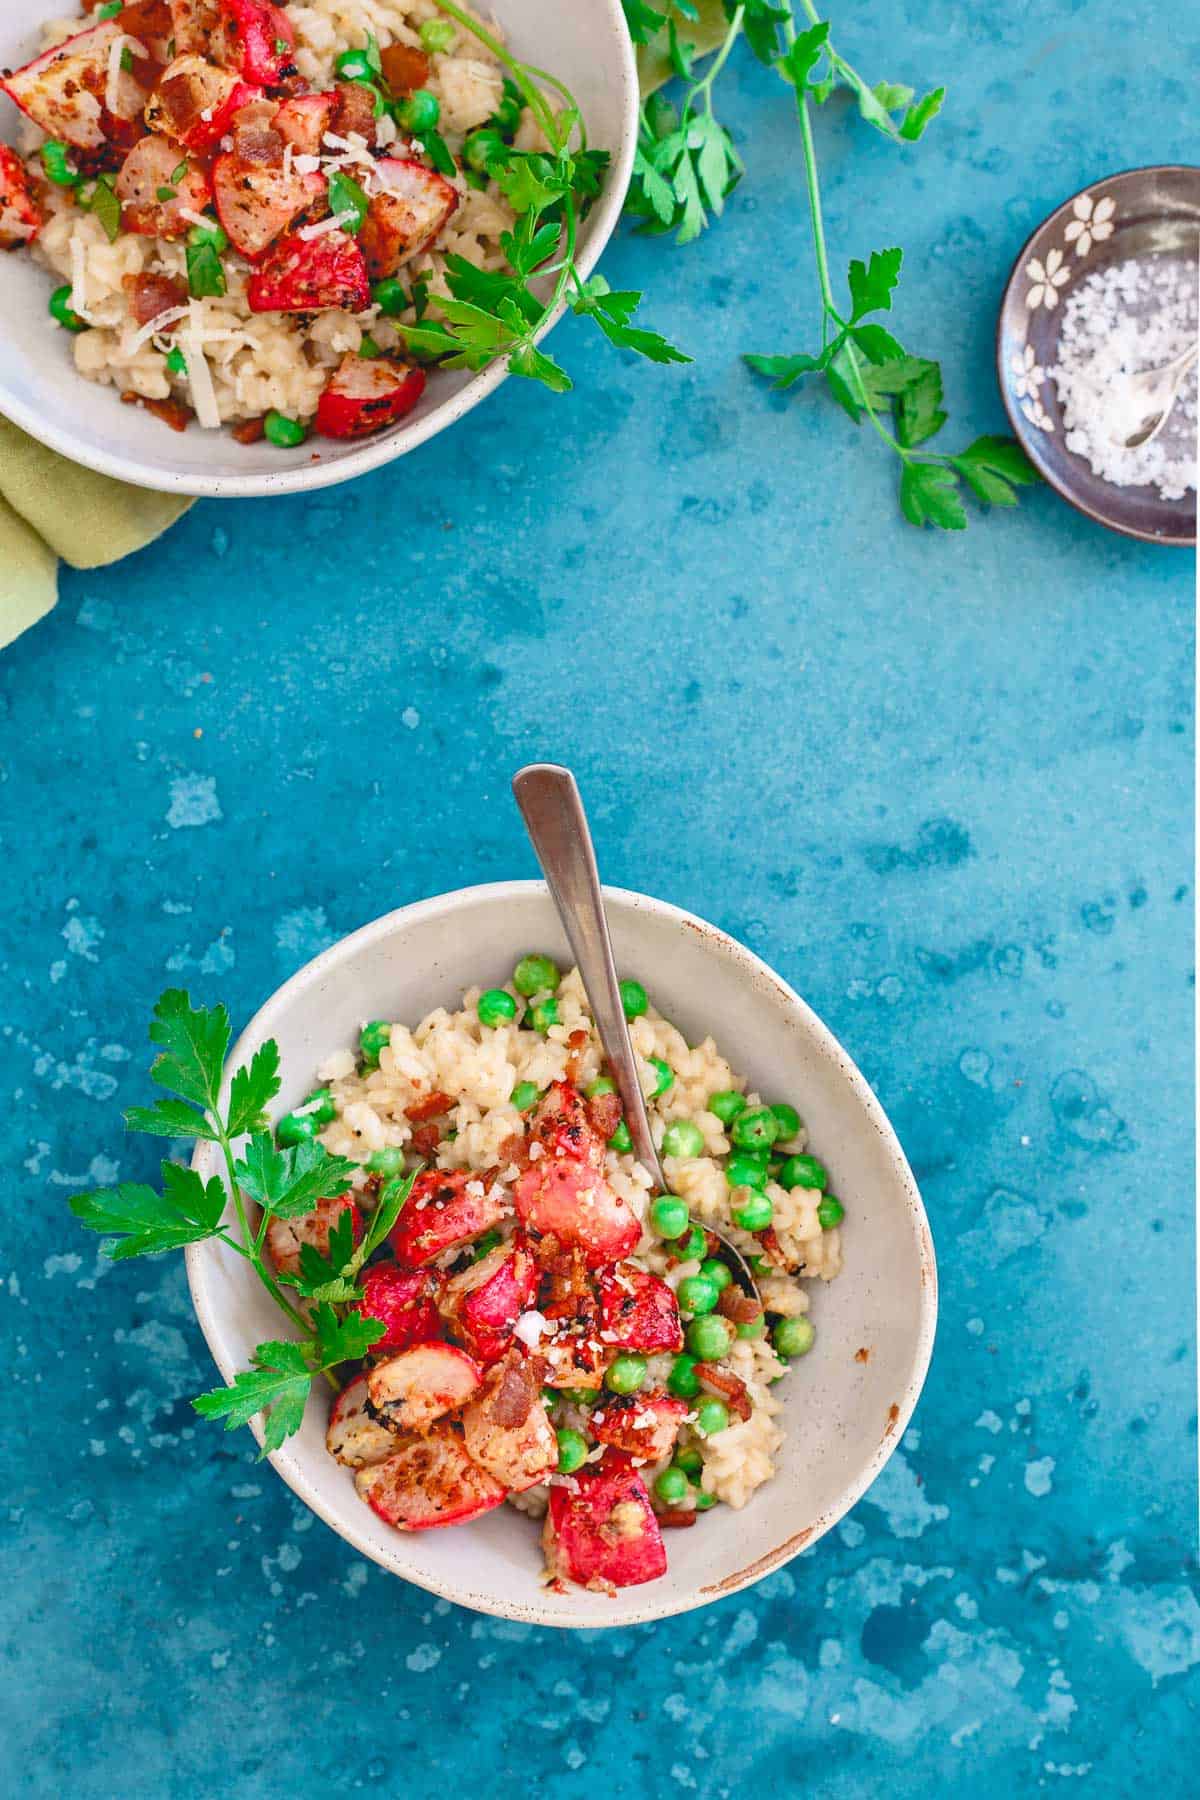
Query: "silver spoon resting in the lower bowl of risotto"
513 763 759 1300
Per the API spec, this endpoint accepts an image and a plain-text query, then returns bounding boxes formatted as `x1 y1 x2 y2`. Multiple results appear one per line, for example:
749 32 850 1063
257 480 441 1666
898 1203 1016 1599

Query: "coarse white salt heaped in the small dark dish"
1047 252 1198 500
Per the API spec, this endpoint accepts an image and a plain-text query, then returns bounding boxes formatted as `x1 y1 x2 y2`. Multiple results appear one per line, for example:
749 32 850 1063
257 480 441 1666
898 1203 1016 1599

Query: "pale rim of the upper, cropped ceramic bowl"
0 0 640 500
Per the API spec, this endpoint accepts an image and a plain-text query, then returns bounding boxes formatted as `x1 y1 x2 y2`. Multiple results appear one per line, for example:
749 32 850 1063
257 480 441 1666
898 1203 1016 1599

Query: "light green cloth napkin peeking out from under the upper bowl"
0 0 727 648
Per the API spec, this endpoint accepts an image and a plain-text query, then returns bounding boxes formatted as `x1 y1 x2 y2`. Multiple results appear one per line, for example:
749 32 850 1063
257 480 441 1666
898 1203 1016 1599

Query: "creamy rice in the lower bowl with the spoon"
318 970 842 1514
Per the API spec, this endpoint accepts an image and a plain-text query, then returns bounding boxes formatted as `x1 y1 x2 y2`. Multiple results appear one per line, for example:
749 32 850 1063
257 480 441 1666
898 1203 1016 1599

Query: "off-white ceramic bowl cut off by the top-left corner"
0 0 639 499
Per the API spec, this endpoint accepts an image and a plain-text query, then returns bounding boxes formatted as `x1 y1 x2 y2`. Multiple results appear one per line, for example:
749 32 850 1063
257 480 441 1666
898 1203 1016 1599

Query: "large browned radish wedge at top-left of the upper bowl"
0 20 143 160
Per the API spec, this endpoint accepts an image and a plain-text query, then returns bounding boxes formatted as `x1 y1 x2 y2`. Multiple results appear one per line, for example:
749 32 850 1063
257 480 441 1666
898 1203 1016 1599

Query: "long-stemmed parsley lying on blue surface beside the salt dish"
622 0 1038 531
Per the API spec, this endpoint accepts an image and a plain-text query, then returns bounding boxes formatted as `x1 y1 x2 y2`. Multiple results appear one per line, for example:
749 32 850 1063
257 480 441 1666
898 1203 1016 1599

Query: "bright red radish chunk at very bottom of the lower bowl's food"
543 1451 667 1593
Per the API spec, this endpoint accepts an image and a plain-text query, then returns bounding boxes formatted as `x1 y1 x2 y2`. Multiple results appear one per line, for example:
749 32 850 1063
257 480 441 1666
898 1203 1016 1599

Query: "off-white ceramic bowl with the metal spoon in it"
187 882 937 1625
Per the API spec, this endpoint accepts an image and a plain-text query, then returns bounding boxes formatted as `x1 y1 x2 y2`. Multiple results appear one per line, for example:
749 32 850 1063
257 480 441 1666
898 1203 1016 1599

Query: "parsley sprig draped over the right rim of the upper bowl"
396 0 691 394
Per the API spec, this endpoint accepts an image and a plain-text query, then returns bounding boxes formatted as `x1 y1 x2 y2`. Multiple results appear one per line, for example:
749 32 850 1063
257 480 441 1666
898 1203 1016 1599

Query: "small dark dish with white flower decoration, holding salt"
997 164 1200 545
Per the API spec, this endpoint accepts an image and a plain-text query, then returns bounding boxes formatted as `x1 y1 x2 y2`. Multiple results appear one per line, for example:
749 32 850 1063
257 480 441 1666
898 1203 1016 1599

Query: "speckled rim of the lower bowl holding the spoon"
185 880 937 1631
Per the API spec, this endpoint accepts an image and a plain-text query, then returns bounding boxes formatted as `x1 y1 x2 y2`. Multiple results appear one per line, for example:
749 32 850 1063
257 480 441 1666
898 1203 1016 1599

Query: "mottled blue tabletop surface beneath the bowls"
0 0 1200 1800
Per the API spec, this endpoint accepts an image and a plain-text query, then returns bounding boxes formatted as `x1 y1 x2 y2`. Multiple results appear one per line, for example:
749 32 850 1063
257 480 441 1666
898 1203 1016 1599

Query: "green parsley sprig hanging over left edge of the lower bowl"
70 988 417 1451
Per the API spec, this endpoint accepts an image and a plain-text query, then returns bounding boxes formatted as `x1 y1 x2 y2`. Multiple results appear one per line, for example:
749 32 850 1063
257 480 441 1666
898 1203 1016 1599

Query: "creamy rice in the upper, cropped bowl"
22 0 528 423
